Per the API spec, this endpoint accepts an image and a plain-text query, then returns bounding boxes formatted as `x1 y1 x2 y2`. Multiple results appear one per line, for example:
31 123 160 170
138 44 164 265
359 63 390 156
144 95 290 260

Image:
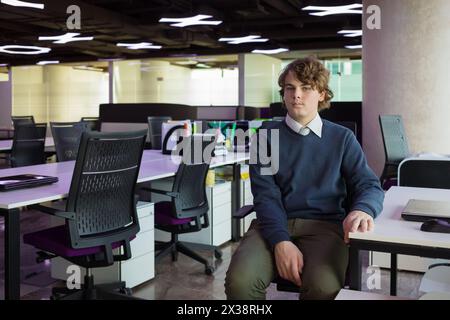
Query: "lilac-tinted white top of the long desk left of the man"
0 150 249 209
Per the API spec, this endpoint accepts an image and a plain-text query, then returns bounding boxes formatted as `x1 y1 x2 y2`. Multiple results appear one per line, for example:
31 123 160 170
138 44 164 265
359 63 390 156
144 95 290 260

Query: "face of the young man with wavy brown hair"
283 71 325 125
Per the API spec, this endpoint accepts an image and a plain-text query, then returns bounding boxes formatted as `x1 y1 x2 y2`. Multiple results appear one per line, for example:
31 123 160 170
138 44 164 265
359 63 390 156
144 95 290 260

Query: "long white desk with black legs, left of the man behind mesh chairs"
0 150 250 299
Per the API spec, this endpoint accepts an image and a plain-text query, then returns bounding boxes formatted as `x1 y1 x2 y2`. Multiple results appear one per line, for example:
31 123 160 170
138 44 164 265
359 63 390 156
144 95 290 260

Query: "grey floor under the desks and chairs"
0 210 421 300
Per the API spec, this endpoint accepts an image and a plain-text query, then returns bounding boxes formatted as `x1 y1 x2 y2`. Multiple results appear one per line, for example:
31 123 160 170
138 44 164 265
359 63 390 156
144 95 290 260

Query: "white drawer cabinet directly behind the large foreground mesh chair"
51 202 155 288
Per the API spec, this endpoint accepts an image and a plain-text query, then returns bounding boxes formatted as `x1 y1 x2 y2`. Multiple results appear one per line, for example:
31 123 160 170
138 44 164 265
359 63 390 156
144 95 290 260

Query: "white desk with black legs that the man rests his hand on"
349 187 450 295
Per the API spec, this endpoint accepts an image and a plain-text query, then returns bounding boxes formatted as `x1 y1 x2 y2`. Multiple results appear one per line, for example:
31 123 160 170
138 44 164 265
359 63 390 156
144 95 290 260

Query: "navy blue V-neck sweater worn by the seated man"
250 120 384 245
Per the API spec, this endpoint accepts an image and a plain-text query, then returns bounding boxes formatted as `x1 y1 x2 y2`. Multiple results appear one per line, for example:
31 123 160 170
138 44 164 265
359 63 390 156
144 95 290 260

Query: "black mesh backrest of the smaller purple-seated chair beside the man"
172 163 209 218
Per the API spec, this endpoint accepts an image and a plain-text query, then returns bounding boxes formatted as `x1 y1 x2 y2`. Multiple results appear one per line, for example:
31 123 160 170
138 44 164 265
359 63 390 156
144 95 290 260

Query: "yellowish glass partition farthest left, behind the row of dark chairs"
12 64 109 122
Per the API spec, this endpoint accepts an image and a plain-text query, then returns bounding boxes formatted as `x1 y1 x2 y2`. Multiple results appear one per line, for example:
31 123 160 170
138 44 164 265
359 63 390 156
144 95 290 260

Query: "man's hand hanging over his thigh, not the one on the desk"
275 241 303 287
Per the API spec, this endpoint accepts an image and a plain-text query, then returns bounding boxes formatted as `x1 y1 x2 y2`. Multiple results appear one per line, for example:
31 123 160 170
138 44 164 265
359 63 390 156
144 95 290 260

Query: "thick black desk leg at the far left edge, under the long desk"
2 209 20 300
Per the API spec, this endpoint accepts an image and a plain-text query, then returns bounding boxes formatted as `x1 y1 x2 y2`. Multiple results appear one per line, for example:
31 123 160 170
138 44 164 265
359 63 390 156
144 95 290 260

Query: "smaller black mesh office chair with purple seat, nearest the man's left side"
146 162 222 275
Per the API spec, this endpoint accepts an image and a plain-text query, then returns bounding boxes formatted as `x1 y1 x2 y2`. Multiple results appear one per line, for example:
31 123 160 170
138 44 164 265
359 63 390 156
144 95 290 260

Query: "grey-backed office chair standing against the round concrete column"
379 115 409 189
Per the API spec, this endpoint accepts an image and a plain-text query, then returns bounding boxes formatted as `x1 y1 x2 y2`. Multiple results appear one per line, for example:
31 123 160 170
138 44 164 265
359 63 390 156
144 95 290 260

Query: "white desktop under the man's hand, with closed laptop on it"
349 187 450 249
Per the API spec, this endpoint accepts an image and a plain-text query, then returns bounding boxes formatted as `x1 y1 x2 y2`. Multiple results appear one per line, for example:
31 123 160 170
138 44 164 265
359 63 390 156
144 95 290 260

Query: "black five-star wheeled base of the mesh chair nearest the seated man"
155 240 222 275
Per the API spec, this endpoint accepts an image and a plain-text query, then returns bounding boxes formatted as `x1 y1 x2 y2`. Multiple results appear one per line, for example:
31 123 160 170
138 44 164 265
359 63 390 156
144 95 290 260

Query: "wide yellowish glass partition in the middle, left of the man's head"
114 56 238 106
